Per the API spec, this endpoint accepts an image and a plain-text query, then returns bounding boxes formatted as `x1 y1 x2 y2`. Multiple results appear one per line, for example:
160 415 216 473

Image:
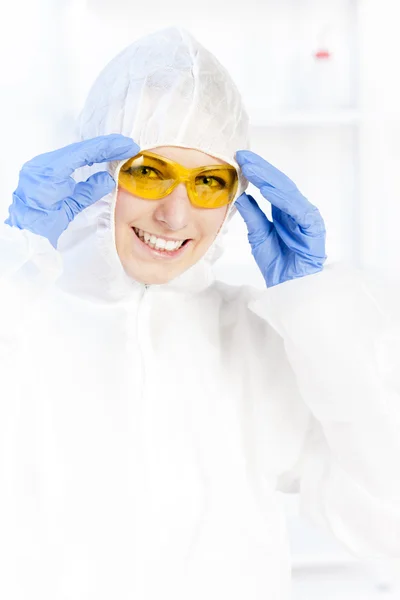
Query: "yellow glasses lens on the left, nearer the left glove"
118 154 174 200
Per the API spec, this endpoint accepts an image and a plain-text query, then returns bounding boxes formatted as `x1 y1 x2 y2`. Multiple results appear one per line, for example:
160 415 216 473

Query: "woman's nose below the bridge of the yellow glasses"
154 183 192 231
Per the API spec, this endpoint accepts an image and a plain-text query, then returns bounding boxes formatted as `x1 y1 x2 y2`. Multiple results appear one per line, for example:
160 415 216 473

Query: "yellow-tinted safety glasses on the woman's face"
118 151 238 208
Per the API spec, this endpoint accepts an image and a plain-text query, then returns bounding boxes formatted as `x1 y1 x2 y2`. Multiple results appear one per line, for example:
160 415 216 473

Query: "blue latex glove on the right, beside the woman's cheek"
235 150 327 287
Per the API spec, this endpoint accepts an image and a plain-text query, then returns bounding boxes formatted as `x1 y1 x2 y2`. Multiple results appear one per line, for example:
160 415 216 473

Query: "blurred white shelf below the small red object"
249 107 362 127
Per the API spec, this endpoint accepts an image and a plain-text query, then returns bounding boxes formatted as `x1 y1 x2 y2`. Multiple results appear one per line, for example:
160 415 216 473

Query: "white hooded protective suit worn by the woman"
0 28 400 600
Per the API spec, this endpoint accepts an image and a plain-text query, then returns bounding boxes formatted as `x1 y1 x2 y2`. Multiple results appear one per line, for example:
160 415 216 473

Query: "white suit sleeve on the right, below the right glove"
249 264 400 558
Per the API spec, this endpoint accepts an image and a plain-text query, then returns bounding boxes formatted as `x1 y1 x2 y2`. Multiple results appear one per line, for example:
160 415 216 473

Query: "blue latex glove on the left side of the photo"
4 133 139 248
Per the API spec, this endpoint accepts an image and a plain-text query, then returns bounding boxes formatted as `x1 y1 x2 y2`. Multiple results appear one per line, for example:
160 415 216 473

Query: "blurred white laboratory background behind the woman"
0 0 400 600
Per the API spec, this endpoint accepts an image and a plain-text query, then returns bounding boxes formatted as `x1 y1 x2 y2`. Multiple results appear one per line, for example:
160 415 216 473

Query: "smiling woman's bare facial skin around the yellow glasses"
115 146 229 285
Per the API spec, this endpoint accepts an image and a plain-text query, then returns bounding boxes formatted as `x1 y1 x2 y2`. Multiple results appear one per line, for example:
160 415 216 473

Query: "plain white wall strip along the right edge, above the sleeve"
358 0 400 278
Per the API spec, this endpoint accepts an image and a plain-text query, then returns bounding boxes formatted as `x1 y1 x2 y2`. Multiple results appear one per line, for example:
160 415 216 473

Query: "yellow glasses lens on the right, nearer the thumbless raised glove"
195 168 237 208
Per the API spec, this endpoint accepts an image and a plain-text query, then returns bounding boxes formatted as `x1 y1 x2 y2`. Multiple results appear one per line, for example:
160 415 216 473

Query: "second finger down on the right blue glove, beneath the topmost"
260 186 324 232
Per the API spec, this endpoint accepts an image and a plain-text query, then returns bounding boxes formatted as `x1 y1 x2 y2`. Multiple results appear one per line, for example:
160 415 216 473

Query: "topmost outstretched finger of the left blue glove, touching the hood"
23 133 140 177
